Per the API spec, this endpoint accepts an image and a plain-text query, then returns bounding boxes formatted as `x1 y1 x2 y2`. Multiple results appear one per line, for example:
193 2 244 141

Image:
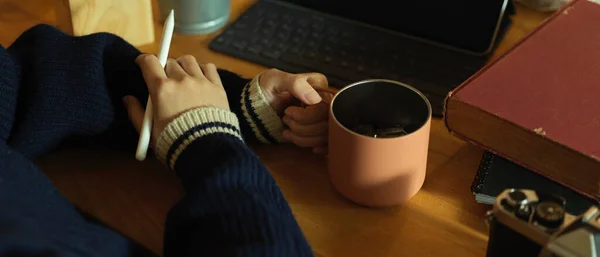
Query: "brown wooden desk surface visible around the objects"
0 0 548 257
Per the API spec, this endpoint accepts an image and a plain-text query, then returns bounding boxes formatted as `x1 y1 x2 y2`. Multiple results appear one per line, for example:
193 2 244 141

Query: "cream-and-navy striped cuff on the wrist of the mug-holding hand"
241 75 285 144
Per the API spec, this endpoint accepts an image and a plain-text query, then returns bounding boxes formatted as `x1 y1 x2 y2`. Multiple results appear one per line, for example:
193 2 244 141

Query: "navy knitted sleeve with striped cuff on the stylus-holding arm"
157 107 312 254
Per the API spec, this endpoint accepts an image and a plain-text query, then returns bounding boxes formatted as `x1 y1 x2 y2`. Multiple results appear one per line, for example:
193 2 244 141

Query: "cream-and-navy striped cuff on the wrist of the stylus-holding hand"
156 107 243 169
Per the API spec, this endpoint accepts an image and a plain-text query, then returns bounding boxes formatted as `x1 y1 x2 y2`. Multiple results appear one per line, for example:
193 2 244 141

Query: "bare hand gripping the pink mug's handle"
259 69 331 153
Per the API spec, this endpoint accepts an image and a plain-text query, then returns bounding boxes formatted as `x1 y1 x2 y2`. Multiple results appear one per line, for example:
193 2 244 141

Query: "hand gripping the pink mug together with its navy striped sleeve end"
219 69 332 153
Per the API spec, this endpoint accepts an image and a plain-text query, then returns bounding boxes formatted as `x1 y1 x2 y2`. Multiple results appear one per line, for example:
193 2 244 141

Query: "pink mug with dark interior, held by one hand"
328 79 431 207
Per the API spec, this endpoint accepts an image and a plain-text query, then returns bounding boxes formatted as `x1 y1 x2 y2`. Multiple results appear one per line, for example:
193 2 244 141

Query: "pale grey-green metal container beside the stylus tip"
158 0 231 34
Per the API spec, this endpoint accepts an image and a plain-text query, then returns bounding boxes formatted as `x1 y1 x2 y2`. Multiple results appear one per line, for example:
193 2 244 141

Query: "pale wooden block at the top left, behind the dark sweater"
56 0 154 46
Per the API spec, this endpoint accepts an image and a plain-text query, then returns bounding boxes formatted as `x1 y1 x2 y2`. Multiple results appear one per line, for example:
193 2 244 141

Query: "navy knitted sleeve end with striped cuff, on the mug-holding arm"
219 70 285 144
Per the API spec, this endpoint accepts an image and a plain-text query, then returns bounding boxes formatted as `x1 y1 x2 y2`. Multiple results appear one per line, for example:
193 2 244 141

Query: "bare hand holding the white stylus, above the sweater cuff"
123 54 229 146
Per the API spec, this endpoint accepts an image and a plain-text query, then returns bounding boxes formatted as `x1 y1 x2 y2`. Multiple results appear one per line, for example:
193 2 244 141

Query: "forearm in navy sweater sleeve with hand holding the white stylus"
125 55 312 257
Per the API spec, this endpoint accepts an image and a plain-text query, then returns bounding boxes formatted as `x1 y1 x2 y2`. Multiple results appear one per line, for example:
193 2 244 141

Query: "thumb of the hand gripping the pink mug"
286 73 327 105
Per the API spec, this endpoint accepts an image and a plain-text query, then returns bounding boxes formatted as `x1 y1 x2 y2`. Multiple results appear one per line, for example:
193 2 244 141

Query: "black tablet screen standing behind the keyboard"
278 0 509 53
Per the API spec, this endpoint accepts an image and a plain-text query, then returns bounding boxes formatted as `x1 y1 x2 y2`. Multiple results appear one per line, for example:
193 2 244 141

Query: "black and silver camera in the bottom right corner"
486 189 600 257
